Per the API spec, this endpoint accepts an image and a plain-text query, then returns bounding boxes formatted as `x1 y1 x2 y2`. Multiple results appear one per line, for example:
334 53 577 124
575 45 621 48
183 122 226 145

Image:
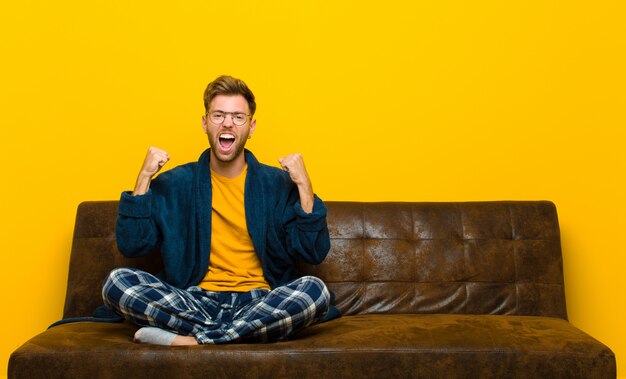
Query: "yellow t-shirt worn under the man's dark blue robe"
200 166 270 292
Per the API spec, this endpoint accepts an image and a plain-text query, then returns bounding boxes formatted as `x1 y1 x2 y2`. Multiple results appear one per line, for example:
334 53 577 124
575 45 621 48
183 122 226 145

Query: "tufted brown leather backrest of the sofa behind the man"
64 201 567 319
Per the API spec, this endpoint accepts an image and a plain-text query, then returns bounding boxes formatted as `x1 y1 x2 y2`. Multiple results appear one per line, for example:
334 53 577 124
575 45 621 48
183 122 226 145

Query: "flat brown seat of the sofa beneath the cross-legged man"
9 314 614 378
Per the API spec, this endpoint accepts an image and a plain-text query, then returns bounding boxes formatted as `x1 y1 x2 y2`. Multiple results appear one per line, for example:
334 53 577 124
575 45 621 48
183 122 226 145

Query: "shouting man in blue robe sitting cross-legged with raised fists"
103 76 336 345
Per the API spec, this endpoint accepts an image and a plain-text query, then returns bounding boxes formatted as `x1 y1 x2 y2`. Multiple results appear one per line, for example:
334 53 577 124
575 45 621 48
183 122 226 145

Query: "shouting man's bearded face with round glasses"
202 95 256 163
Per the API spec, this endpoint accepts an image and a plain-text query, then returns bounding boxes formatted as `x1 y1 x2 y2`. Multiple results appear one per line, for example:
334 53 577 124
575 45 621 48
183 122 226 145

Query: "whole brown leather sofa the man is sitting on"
8 201 616 379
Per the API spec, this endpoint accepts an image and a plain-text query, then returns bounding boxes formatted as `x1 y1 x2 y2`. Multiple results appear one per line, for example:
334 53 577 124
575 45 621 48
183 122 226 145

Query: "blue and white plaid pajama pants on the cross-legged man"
102 268 330 344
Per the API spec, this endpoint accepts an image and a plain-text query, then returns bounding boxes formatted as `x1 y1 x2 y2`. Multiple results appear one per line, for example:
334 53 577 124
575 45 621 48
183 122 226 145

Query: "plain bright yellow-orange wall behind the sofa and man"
0 0 626 377
